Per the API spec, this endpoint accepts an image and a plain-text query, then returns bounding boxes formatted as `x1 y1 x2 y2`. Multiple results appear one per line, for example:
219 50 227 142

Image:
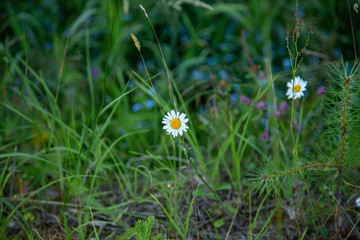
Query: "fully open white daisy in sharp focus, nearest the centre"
162 110 189 137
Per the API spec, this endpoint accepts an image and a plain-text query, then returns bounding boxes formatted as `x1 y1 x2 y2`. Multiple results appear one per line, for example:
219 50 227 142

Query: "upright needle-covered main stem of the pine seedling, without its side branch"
326 58 360 206
